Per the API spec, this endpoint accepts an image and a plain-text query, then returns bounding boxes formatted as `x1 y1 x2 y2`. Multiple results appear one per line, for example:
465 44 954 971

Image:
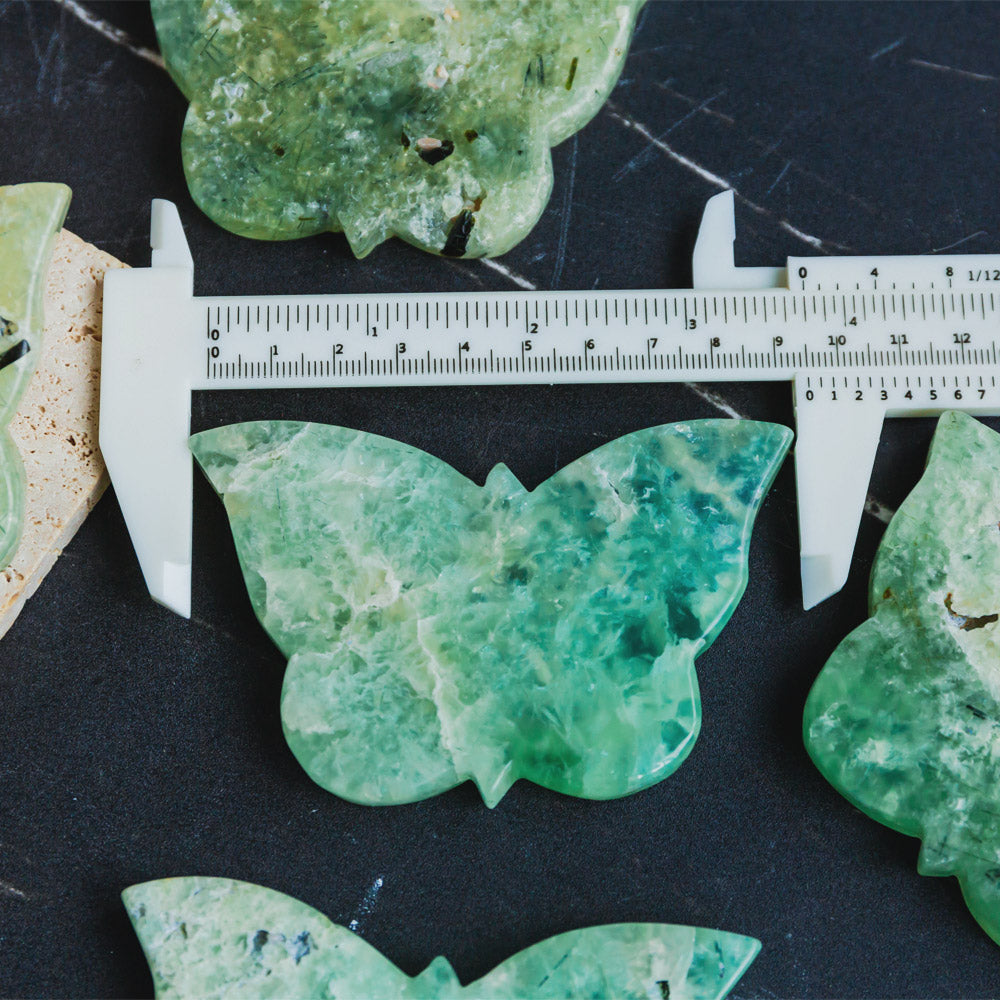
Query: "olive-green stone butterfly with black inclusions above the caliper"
152 0 641 257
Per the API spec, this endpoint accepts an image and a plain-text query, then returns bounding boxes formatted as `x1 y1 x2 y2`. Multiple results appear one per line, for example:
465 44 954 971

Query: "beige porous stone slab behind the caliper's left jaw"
0 229 125 636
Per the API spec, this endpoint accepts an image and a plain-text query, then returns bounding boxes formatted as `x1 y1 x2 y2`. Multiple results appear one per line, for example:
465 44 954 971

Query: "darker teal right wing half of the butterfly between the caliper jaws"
429 420 791 804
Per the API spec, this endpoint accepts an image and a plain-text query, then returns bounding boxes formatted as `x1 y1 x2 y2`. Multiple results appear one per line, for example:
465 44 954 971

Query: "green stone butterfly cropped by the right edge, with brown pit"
805 413 1000 943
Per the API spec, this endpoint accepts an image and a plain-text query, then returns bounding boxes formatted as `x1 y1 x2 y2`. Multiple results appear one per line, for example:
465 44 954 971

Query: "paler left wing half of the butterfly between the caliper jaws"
191 421 482 804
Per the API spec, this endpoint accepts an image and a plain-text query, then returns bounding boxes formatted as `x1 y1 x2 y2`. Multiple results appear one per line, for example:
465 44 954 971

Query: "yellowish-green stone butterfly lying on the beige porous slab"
0 184 70 569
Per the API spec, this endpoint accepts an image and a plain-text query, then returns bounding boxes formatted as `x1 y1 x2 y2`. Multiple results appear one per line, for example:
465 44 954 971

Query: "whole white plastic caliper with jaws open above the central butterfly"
101 192 1000 615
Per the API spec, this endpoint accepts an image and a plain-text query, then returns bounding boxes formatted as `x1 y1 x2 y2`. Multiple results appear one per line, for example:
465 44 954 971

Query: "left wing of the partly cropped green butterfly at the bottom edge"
122 878 411 1000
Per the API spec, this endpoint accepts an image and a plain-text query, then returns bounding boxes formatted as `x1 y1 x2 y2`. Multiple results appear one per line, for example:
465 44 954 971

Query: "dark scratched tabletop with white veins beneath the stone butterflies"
0 2 1000 998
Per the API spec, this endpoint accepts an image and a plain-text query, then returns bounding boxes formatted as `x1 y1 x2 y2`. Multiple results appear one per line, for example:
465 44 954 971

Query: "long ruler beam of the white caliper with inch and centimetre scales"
194 290 1000 392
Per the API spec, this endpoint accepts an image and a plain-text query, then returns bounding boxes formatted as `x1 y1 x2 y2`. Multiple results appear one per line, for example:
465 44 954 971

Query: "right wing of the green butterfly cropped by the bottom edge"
466 924 760 1000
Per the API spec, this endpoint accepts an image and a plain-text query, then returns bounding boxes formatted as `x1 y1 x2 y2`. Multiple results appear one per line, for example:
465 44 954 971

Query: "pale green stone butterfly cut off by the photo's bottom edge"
122 878 760 1000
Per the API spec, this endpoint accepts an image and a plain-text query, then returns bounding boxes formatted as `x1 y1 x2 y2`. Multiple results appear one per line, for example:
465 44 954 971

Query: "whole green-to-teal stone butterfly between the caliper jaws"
191 420 791 806
